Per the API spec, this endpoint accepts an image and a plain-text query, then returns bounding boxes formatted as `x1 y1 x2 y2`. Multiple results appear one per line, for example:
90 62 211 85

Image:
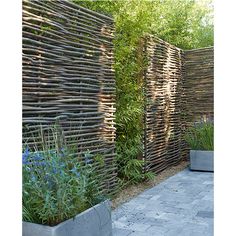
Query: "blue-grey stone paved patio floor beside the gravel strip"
112 169 214 236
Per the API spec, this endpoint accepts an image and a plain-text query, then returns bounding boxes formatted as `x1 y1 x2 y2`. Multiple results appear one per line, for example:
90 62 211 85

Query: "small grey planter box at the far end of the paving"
190 150 214 171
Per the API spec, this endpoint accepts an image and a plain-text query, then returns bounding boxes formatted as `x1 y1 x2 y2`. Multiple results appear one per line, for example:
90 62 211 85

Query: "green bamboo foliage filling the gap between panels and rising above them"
73 0 213 182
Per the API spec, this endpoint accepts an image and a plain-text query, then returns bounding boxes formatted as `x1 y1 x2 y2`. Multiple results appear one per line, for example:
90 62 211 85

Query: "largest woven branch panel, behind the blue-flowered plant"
22 0 117 190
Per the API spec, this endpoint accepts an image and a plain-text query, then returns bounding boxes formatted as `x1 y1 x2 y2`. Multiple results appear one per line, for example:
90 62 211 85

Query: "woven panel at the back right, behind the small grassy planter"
184 47 214 122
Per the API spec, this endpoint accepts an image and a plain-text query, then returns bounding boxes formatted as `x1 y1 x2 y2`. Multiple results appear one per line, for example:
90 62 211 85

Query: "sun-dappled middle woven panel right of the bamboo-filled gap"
144 36 186 173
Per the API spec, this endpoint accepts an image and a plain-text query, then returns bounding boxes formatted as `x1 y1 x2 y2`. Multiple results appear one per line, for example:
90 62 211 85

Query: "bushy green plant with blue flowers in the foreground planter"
22 126 105 226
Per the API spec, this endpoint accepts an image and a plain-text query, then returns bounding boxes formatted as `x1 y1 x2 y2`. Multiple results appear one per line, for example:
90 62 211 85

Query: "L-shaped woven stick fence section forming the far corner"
144 36 214 173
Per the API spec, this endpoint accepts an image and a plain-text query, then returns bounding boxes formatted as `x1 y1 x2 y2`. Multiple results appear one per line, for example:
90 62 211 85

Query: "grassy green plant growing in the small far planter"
185 122 214 151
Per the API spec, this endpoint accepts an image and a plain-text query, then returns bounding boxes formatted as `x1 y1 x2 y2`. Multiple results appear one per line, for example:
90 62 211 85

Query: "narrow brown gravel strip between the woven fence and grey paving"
112 161 189 209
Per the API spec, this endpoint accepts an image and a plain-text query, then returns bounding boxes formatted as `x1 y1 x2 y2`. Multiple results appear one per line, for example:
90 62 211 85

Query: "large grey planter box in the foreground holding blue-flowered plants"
22 200 112 236
